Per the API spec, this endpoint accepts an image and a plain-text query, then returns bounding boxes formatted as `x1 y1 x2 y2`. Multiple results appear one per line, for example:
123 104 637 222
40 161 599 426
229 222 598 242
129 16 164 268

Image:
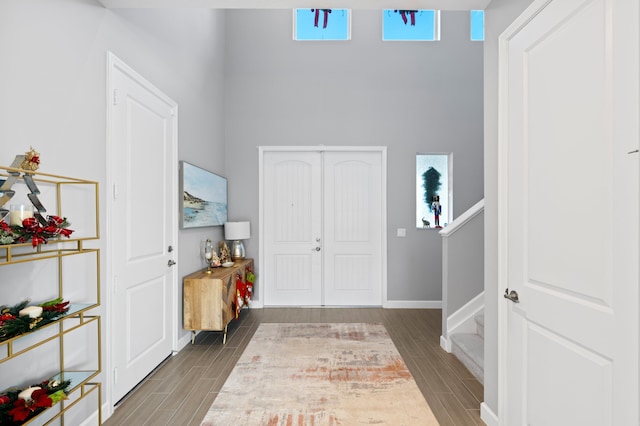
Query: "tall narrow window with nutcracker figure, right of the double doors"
416 154 452 229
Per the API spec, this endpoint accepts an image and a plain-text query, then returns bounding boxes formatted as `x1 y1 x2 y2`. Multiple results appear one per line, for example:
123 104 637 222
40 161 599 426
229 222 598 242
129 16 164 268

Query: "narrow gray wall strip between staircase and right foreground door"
484 0 533 414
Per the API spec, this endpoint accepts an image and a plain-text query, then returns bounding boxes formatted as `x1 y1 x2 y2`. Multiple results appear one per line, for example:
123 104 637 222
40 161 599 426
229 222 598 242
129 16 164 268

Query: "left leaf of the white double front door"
263 152 322 306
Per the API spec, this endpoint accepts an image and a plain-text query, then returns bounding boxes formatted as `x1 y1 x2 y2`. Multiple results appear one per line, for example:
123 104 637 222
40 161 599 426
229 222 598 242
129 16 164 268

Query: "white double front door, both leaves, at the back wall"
261 148 386 306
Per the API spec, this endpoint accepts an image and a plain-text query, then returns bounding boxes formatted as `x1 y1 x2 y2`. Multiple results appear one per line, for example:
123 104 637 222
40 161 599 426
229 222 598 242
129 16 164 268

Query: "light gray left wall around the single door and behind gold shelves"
0 0 226 412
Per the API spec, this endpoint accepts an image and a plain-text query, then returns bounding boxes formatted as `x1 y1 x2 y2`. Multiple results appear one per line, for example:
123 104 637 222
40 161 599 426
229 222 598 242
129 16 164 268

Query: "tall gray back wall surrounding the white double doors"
225 10 483 301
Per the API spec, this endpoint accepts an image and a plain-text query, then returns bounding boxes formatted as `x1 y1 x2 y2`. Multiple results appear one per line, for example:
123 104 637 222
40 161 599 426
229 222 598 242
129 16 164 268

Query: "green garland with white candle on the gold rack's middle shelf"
0 297 69 342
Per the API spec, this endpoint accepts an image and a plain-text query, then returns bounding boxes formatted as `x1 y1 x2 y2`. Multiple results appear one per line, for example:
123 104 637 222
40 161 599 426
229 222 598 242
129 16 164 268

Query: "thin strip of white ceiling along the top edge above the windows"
99 0 491 10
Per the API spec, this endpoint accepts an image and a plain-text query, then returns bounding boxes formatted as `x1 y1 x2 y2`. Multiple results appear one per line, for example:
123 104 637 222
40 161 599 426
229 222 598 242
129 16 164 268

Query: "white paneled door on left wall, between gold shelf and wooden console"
110 58 178 402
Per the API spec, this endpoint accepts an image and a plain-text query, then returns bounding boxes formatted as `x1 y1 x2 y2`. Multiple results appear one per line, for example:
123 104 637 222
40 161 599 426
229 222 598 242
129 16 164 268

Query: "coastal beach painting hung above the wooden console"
180 161 227 229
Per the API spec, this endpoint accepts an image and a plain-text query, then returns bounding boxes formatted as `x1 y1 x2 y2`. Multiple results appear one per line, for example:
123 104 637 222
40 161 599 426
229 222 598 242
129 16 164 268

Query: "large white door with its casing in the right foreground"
499 0 640 426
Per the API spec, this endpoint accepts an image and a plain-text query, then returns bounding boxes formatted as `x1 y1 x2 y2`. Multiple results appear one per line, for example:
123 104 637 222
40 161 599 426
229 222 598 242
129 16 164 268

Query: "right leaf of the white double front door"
324 152 383 306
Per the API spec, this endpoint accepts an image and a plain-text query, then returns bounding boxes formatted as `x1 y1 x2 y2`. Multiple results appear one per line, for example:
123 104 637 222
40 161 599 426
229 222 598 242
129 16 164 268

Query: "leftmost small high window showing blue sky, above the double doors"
294 9 349 40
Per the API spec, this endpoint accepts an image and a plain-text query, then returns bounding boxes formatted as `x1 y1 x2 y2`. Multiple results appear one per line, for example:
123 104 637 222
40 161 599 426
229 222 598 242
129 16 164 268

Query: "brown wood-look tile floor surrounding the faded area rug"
104 308 484 426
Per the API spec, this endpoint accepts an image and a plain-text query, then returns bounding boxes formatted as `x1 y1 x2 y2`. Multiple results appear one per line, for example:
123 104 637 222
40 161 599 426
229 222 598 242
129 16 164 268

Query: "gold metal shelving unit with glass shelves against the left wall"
0 166 102 424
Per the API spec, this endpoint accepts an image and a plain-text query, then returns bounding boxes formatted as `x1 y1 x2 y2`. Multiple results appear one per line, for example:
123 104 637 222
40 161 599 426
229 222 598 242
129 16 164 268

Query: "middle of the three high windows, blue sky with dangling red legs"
382 9 439 41
